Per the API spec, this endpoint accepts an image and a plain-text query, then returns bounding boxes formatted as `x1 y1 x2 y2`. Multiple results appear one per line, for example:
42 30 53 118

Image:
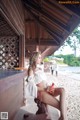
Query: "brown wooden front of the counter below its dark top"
0 72 26 120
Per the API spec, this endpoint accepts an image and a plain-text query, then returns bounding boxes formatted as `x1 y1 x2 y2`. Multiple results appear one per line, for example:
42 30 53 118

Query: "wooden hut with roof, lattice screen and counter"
0 0 80 120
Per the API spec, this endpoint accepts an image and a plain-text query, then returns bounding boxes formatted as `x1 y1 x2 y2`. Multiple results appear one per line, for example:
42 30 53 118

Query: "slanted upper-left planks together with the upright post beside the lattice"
0 0 25 67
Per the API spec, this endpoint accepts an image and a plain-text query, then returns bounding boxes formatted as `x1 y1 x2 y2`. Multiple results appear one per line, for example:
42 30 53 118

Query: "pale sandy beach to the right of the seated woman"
47 72 80 120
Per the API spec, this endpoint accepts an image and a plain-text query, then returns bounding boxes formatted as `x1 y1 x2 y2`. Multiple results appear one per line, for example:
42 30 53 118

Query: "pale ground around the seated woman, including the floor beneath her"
14 73 80 120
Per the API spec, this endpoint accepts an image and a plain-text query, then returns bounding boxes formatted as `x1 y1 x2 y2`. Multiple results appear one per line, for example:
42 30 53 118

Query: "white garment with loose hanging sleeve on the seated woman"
26 65 52 98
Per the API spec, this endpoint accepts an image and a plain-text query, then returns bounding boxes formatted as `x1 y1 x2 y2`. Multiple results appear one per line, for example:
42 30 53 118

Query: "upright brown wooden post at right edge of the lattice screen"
19 35 25 67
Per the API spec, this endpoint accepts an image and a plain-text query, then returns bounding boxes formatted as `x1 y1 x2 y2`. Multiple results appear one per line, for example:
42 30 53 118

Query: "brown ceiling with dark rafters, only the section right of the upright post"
23 0 80 54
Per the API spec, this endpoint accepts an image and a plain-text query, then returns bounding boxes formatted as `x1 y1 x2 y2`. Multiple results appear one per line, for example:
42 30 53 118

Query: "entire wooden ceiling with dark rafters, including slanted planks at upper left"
0 0 80 57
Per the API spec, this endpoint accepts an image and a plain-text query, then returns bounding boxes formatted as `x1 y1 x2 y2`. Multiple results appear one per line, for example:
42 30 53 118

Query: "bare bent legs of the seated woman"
42 88 67 120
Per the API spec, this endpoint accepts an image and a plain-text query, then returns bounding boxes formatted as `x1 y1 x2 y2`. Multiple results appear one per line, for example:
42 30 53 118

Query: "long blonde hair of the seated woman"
28 51 41 76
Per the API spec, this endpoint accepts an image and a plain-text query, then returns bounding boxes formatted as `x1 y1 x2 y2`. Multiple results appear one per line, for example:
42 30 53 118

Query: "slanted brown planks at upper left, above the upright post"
0 0 25 35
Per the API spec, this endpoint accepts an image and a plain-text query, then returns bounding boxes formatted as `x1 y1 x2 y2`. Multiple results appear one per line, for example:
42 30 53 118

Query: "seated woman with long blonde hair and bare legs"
28 52 67 120
